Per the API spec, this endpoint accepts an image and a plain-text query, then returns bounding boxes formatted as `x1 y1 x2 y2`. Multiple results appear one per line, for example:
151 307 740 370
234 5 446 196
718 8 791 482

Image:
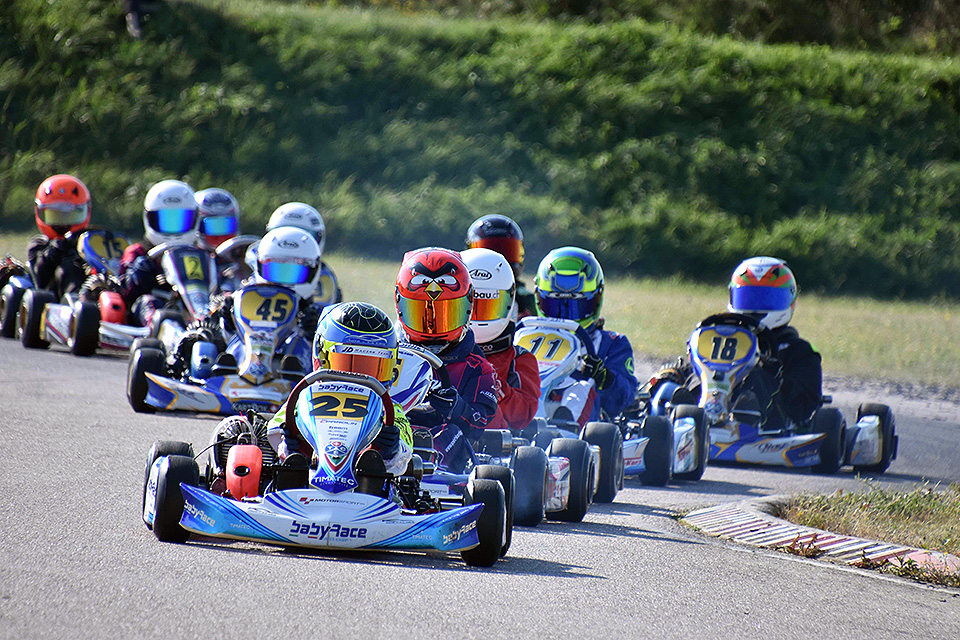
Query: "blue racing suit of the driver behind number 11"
544 318 637 426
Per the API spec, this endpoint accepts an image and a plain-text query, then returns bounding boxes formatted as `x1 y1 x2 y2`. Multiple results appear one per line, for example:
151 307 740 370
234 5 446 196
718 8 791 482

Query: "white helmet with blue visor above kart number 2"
143 180 198 250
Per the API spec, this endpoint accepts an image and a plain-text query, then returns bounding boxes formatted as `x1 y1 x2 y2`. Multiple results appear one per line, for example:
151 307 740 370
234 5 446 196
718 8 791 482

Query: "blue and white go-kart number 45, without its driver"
127 284 311 415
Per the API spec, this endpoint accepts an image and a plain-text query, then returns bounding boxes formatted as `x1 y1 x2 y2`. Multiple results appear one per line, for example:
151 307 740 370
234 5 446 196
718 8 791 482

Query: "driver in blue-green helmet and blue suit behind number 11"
534 247 637 426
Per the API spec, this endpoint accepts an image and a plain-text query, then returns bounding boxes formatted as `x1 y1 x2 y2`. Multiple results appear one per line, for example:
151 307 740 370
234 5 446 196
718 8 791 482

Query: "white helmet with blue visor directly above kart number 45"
254 227 320 298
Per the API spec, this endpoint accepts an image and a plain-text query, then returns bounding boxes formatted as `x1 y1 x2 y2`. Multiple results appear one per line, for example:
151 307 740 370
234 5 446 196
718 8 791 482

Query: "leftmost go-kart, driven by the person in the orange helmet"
16 229 130 356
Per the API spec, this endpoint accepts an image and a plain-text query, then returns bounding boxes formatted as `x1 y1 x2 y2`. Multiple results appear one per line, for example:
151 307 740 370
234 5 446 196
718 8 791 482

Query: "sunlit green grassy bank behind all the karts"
0 0 960 300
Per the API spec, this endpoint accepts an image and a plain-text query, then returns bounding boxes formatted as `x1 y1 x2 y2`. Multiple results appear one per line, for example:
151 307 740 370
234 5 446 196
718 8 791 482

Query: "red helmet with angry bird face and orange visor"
396 247 473 345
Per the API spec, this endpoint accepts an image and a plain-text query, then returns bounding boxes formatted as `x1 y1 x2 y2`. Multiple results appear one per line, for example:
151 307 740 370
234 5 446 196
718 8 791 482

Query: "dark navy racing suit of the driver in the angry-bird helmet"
409 330 497 473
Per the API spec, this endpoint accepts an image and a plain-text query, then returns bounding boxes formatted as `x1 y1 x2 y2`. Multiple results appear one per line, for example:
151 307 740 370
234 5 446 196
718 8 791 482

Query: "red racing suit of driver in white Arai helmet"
480 330 540 431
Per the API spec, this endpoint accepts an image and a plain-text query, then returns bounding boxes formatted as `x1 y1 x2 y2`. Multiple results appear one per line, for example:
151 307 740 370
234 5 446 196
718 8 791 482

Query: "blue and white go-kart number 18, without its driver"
651 313 898 473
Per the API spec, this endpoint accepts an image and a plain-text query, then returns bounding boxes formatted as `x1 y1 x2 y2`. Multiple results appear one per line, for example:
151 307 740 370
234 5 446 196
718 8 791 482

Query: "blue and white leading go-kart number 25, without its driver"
143 370 507 566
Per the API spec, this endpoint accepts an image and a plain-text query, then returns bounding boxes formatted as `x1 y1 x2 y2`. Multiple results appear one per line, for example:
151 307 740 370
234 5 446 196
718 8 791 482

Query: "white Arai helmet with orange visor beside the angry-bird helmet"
460 249 517 344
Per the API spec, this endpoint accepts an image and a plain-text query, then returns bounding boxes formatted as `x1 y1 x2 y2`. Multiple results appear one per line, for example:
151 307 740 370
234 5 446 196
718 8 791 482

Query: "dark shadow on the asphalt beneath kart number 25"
186 528 604 578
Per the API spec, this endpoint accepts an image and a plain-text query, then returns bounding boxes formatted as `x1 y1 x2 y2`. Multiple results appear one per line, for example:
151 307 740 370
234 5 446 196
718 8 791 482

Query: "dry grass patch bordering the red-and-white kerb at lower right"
778 481 960 587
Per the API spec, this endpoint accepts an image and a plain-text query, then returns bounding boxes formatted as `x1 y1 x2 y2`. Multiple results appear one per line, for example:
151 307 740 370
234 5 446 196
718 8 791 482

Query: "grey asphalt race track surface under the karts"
0 340 960 640
